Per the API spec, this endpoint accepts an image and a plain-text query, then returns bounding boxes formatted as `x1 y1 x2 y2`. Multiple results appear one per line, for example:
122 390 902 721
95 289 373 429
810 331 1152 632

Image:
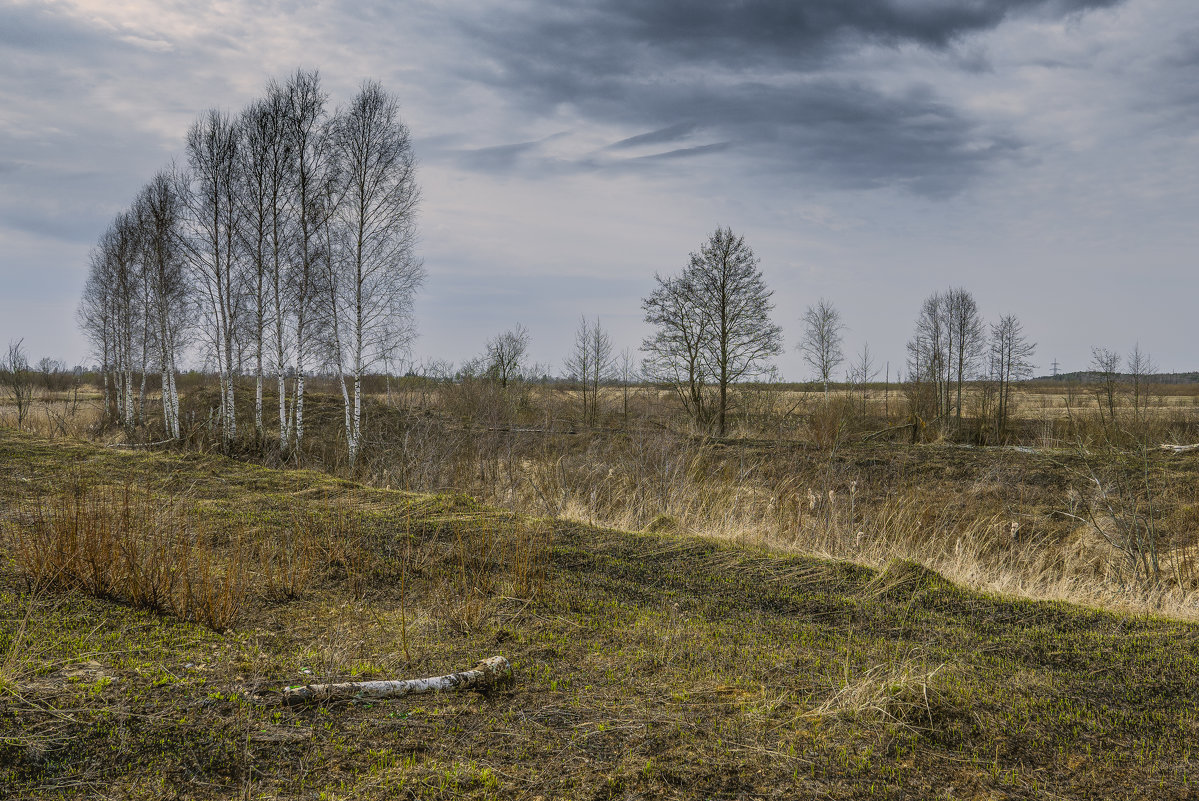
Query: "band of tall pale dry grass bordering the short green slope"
345 393 1199 618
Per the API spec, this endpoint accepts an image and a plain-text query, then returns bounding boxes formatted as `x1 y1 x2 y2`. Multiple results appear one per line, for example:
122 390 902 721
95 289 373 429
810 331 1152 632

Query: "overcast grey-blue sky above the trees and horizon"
0 0 1199 379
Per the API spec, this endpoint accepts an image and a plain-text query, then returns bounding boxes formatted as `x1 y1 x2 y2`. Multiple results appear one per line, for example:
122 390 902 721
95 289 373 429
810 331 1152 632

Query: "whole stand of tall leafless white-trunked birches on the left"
79 71 424 465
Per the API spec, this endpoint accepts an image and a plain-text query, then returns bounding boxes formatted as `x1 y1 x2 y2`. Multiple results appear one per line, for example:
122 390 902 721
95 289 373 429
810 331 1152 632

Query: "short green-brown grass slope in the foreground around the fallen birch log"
0 429 1199 799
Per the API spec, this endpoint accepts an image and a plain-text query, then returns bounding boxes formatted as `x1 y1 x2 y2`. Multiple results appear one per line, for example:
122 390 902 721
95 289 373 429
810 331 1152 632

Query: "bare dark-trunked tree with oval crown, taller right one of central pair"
686 228 783 436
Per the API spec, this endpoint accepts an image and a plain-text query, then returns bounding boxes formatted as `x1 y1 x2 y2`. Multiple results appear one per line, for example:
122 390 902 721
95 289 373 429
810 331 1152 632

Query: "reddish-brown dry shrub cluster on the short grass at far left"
5 481 249 631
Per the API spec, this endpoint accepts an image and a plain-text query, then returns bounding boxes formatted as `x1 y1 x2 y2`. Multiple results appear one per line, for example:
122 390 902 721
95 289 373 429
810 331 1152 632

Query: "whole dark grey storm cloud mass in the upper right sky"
450 0 1121 195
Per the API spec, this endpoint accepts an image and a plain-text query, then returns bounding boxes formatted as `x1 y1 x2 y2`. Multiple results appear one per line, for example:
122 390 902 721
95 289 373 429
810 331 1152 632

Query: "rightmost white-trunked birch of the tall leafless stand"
330 82 424 466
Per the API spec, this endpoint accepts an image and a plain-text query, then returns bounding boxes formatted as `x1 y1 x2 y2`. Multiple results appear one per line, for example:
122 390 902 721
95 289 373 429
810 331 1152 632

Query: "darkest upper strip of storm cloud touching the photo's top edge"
469 0 1123 74
